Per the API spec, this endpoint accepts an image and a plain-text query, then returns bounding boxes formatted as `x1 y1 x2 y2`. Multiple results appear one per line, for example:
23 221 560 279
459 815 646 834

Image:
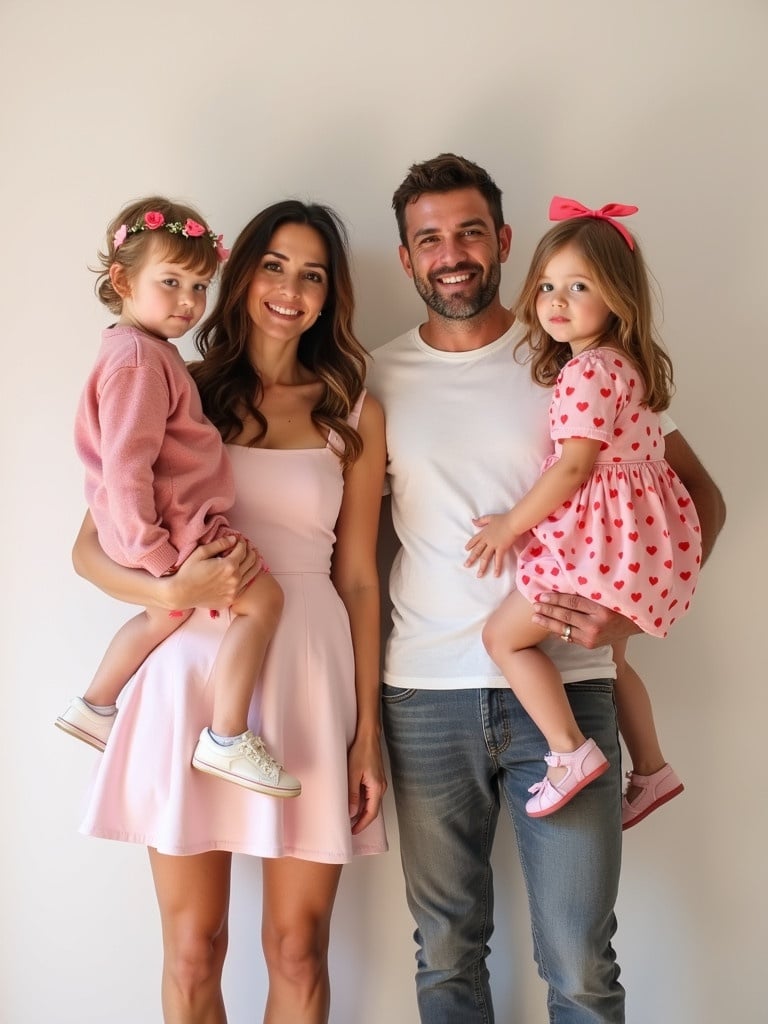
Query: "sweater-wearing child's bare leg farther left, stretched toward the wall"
83 608 191 707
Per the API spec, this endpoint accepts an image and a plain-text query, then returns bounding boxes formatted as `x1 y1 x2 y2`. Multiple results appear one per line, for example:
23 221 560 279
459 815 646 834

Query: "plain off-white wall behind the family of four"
0 0 768 1024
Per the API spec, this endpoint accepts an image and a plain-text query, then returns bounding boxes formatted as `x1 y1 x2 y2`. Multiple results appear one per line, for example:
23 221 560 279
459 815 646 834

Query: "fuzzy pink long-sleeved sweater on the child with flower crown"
75 327 234 577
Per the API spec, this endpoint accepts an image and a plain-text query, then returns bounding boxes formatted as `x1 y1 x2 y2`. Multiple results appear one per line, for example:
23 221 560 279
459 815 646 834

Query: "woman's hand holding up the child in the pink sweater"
167 536 264 608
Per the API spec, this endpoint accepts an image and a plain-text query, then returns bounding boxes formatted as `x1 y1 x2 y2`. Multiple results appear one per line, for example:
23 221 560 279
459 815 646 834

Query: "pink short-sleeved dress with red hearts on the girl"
517 348 701 637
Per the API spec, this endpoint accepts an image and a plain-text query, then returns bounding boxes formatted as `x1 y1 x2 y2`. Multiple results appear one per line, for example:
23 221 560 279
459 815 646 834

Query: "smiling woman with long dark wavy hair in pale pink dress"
75 201 386 1024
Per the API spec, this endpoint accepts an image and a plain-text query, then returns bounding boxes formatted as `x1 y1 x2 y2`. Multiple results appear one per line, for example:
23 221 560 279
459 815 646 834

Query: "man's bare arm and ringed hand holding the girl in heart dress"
534 430 725 648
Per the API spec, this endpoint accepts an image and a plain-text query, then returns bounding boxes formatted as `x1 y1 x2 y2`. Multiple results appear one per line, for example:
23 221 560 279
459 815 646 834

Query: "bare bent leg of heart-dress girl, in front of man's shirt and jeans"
482 591 586 782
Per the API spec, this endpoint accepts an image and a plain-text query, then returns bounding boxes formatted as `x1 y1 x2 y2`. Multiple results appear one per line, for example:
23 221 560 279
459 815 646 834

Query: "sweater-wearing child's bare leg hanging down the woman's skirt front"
211 572 283 736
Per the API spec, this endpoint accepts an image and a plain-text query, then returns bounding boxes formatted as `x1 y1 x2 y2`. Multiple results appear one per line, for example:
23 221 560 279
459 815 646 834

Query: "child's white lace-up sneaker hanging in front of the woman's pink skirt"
193 728 301 797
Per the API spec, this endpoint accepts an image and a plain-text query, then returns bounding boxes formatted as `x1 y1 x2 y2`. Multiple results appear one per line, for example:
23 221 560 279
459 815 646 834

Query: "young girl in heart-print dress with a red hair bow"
467 197 701 828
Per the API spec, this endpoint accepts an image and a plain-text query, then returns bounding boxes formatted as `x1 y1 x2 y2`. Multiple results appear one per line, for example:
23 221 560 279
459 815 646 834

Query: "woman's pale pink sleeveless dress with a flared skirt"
81 395 387 863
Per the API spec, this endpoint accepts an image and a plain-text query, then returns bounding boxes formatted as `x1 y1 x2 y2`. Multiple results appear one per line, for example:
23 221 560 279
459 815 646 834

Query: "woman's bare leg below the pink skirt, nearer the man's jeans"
261 857 341 1024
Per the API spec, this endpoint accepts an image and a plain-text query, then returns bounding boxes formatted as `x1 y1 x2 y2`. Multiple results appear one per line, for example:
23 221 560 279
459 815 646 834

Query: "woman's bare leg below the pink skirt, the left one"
150 849 231 1024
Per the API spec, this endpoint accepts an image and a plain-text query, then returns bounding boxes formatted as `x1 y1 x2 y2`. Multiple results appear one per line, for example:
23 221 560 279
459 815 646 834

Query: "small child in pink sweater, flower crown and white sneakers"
56 197 301 797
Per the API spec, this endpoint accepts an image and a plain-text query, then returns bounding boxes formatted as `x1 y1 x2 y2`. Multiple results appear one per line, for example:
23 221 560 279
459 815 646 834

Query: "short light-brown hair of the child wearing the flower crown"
93 196 219 314
